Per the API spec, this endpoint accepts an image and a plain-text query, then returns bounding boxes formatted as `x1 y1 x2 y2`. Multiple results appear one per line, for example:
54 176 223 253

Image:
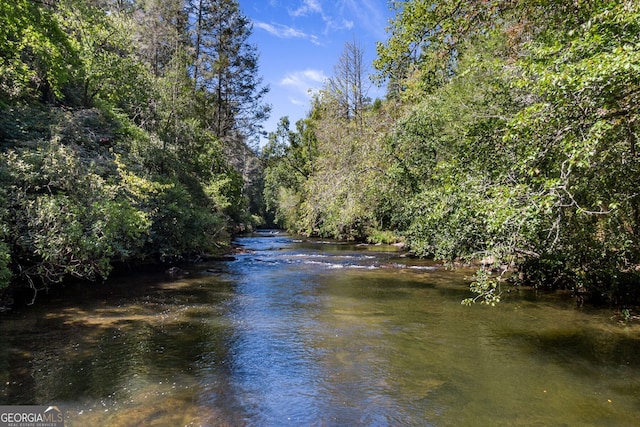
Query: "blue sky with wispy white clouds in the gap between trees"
239 0 392 145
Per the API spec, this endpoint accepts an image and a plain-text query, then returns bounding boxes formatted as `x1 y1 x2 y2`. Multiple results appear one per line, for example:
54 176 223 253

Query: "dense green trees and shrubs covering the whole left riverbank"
0 0 269 304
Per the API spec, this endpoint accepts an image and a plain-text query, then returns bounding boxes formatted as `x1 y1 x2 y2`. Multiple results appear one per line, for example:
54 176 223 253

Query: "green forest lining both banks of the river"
0 0 640 307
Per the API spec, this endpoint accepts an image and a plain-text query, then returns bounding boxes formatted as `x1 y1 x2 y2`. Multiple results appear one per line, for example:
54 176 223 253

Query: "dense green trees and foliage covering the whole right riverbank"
265 0 640 305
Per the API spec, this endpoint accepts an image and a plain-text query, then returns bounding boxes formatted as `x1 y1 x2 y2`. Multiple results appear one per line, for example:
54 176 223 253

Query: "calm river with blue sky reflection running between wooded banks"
0 232 640 426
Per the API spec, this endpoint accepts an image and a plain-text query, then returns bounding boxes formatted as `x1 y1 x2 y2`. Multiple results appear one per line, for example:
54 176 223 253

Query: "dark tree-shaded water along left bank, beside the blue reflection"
0 274 255 426
